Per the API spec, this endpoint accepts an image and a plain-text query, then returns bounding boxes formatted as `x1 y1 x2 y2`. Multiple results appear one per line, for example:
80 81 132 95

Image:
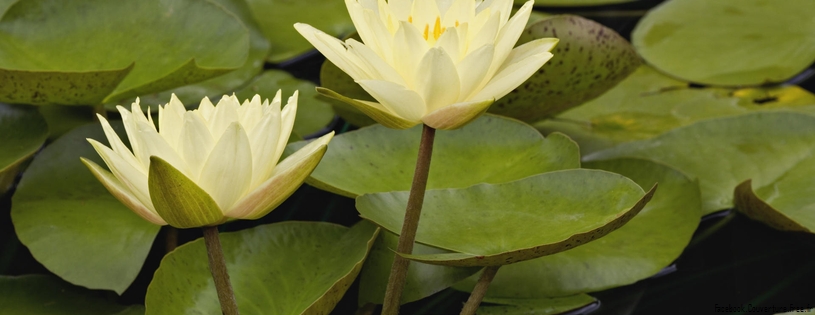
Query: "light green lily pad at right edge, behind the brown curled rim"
584 112 815 217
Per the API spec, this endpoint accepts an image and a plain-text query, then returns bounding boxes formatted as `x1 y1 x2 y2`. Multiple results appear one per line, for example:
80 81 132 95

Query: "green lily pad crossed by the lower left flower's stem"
145 221 378 315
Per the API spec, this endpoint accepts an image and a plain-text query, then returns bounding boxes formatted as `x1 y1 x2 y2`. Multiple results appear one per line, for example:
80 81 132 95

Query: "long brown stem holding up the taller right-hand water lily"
382 125 436 315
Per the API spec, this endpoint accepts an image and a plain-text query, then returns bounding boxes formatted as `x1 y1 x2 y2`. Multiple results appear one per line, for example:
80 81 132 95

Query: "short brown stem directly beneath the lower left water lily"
201 226 239 315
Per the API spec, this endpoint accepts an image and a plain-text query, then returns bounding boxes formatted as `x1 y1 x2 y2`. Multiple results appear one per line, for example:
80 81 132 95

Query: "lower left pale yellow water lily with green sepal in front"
82 91 333 228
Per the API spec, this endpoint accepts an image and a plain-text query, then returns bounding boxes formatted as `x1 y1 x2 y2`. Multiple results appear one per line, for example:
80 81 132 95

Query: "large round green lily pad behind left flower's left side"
11 123 159 294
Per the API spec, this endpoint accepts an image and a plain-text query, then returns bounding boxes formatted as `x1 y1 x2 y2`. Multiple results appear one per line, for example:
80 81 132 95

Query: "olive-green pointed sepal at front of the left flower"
147 156 226 229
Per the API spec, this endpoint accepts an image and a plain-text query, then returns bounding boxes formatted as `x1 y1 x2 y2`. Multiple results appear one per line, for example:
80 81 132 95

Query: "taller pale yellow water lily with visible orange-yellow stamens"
294 0 558 129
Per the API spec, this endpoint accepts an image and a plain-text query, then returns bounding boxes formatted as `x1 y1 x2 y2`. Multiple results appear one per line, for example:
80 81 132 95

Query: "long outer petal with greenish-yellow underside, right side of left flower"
226 132 334 219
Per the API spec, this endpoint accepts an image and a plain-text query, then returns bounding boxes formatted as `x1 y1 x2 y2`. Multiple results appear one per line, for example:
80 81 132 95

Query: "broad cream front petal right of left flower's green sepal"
198 122 252 214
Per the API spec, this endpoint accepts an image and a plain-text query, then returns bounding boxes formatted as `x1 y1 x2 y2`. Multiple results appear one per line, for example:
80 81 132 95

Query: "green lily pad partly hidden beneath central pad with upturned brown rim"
455 159 701 299
